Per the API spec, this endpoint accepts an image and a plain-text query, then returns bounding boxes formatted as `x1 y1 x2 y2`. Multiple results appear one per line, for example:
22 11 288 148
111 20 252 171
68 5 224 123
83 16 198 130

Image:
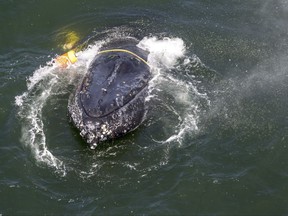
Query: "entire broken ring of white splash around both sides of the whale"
15 34 207 178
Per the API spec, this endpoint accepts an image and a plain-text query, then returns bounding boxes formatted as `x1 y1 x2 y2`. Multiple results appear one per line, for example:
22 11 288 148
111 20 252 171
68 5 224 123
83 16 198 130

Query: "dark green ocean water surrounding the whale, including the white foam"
0 0 288 215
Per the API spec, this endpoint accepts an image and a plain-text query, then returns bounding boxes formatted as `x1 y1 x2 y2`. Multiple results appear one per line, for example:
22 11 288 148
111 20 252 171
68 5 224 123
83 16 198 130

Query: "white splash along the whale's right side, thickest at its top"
138 37 209 145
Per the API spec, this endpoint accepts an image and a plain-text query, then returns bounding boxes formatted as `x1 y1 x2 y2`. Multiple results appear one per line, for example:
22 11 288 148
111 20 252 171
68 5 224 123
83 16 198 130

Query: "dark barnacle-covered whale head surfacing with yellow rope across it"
68 39 151 149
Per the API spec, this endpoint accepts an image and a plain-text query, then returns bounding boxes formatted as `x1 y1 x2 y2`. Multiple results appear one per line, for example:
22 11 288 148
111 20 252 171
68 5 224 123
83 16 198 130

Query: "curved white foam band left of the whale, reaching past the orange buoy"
15 43 101 175
